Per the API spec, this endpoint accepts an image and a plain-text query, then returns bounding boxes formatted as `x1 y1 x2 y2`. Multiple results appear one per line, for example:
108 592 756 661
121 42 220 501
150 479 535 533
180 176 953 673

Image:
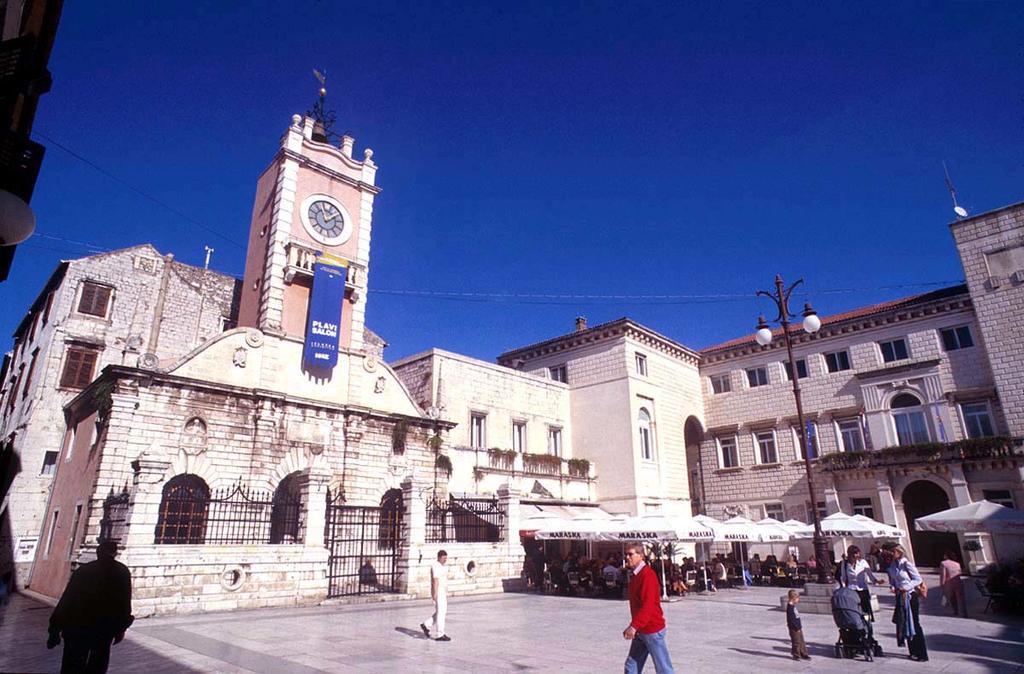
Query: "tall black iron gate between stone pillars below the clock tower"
324 492 401 597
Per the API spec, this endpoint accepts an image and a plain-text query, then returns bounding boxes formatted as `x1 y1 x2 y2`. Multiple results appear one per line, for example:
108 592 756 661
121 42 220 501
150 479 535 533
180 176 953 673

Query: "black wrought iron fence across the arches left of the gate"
156 475 303 545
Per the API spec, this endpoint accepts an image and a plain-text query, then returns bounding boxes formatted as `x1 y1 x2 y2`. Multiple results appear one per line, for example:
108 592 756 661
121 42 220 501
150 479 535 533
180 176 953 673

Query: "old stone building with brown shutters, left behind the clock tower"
0 244 241 587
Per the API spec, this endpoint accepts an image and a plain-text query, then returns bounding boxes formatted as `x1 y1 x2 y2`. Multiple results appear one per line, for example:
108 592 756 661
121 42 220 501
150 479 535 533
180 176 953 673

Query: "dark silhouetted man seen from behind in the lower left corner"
46 541 134 674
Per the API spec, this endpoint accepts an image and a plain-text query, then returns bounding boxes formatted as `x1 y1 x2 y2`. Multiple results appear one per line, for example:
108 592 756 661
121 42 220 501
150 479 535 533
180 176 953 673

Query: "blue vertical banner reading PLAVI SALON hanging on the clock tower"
302 262 348 370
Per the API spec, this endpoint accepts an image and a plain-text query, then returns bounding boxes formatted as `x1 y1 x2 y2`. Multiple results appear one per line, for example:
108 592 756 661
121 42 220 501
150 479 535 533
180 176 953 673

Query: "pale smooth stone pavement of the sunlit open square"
0 573 1024 674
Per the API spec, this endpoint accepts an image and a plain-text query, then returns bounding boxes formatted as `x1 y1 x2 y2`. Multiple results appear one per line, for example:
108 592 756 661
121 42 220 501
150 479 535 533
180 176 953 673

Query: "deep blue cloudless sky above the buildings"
0 1 1024 359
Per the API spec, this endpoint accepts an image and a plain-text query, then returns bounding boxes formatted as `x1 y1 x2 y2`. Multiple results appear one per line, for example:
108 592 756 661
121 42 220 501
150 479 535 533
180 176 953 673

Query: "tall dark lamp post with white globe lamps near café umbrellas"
755 275 830 584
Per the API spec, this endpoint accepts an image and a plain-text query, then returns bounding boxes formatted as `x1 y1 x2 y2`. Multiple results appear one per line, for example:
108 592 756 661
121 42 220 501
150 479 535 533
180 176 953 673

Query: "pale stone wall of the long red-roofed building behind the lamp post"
700 294 1006 520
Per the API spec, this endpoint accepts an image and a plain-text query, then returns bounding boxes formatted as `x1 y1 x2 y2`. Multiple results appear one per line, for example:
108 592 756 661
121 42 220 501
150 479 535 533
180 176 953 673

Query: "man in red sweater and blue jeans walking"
623 543 675 674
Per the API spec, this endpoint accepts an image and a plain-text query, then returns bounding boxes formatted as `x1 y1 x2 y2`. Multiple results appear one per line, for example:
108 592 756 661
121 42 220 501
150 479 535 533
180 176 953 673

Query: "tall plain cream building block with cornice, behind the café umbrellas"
498 319 705 515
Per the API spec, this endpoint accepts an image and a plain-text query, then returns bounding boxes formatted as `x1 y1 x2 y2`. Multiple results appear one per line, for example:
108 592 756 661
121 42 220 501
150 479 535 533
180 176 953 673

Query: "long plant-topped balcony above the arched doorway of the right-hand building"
816 436 1024 472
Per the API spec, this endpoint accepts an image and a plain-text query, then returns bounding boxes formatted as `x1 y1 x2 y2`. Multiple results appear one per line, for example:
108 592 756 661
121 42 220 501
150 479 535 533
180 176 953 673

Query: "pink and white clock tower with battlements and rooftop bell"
239 106 380 353
